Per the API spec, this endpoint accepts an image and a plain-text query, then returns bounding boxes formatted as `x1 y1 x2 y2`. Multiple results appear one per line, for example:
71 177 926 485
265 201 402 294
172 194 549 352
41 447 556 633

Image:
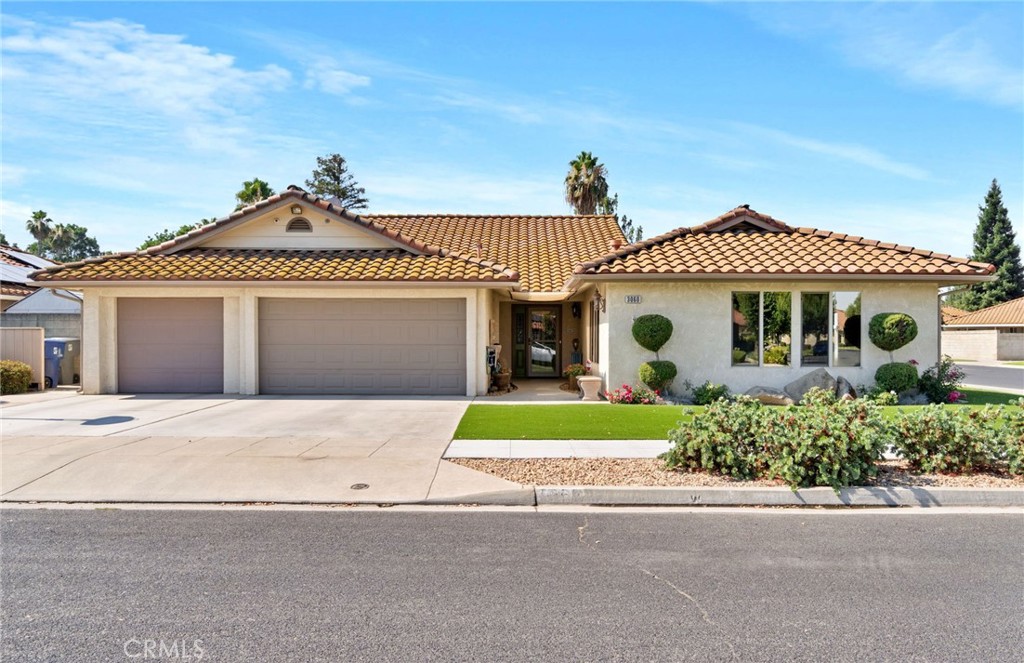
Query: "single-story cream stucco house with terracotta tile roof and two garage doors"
34 187 993 396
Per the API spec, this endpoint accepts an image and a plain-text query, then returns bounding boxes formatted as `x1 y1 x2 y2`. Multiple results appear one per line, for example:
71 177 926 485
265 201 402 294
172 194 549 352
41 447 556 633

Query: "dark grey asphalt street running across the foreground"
0 508 1024 662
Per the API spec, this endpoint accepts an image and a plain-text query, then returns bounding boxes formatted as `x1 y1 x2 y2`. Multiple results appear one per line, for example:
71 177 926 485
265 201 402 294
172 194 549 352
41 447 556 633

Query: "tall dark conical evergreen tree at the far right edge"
950 179 1024 310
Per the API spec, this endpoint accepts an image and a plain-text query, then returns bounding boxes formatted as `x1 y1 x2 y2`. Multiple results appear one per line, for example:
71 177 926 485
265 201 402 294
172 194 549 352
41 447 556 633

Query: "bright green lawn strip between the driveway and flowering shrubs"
455 404 694 440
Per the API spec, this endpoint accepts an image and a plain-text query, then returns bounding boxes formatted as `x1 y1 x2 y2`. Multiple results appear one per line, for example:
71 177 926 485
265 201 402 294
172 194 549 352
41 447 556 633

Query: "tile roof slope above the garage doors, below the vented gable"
34 249 516 283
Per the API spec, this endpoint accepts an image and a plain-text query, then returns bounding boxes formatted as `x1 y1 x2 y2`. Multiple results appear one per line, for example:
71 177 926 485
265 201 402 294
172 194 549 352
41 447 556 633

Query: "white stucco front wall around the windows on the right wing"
601 281 939 392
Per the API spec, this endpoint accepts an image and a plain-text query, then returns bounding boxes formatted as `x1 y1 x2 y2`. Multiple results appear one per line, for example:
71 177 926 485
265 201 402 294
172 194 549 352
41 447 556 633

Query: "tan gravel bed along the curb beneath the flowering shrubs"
450 458 1024 488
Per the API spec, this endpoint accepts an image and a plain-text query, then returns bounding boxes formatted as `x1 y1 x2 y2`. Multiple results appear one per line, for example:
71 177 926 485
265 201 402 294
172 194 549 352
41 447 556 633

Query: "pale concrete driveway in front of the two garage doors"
0 395 526 503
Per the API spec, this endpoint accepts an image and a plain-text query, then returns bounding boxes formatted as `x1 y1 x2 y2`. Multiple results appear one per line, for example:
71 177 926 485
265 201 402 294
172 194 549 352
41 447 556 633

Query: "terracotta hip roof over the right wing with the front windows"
575 207 994 280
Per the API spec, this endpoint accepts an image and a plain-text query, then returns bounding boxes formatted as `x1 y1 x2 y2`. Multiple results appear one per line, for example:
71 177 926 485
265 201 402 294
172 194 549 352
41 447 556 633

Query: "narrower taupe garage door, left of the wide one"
118 297 224 393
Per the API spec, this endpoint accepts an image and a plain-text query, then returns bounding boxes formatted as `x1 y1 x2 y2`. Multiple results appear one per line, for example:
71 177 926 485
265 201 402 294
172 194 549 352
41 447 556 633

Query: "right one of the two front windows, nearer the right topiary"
800 292 862 366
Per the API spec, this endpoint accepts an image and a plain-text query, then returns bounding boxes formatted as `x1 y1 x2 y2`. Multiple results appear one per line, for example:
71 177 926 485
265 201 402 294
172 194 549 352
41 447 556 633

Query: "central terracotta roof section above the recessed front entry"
364 214 626 292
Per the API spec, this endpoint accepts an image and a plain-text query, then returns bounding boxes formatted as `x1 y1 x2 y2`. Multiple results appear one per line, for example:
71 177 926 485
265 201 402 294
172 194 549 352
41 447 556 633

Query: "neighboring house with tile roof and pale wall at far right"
942 297 1024 361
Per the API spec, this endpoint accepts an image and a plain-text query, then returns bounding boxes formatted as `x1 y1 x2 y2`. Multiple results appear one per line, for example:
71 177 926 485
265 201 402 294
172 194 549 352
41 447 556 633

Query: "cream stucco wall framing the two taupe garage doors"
82 286 496 396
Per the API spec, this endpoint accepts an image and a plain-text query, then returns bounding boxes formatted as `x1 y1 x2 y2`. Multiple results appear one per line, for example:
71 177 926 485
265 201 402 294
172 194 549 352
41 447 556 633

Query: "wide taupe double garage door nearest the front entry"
259 299 466 395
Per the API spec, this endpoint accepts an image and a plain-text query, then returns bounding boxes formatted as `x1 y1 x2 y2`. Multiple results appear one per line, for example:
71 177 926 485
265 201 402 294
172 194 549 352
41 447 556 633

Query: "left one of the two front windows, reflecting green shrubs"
732 292 793 366
